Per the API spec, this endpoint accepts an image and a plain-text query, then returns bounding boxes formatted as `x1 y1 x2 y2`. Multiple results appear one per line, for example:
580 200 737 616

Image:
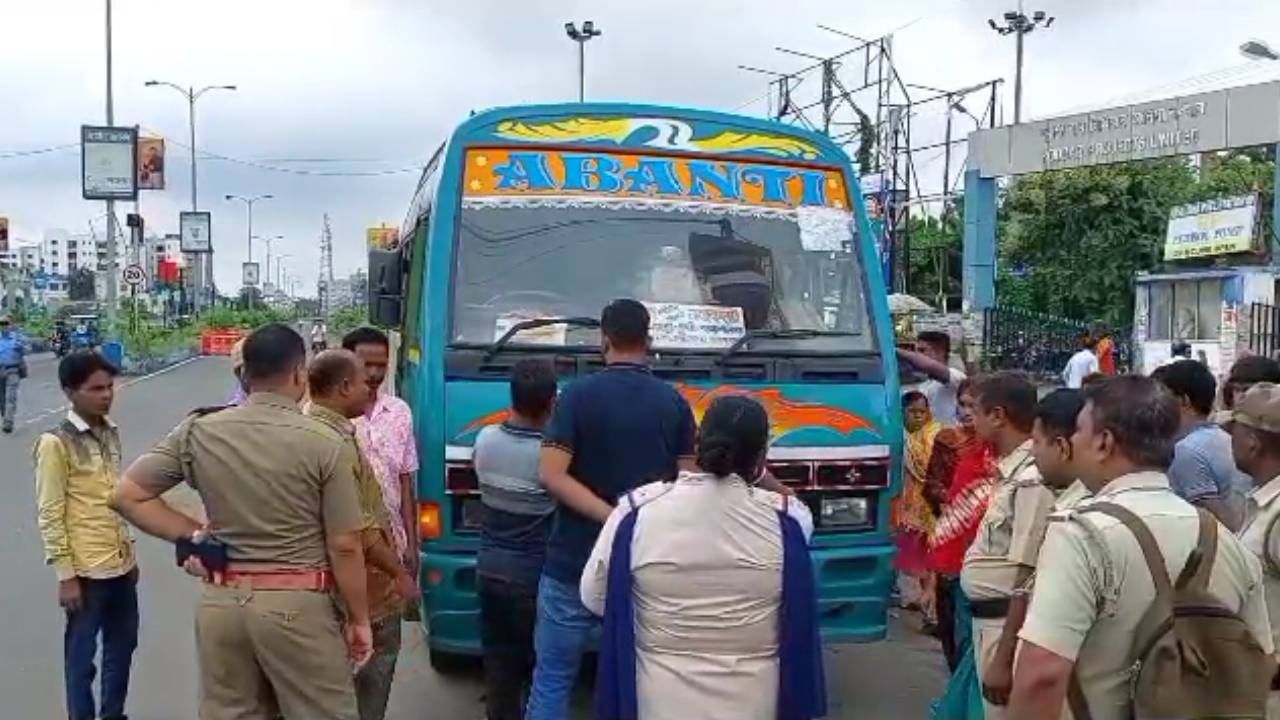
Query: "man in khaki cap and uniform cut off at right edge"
1228 383 1280 719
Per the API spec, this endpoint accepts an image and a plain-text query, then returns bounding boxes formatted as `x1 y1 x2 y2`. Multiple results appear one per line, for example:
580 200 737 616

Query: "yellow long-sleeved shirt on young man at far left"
35 411 136 580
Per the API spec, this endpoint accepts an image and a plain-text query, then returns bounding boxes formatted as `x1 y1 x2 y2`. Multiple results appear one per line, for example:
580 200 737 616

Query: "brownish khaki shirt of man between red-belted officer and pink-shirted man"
303 402 403 623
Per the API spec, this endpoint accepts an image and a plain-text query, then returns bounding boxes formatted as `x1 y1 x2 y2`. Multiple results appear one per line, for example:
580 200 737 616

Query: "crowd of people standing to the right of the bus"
893 333 1280 720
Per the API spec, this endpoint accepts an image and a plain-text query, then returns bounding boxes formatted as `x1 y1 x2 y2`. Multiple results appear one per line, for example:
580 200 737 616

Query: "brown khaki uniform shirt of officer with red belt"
138 392 365 568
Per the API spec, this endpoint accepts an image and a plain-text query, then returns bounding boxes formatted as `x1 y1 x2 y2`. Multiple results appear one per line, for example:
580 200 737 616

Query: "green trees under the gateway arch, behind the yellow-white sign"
996 149 1275 327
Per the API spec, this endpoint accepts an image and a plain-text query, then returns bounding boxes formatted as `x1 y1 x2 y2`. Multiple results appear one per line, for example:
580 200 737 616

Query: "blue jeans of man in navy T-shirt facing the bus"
525 575 600 720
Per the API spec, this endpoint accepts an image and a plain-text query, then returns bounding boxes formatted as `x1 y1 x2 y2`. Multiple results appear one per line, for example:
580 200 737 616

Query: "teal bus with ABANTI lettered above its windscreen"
370 104 902 670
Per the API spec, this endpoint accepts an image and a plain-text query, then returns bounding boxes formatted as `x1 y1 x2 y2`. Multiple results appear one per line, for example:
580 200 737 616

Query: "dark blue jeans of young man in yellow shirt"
63 573 138 720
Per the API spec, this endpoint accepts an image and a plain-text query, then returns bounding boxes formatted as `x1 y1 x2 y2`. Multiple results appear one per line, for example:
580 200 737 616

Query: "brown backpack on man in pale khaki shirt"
1068 502 1276 720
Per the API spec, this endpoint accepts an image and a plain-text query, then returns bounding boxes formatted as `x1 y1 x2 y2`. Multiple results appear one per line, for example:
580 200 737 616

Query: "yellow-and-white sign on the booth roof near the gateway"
1165 195 1258 260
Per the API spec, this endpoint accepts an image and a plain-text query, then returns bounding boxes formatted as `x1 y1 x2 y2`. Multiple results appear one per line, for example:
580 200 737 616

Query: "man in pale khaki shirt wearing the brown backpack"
1007 375 1275 720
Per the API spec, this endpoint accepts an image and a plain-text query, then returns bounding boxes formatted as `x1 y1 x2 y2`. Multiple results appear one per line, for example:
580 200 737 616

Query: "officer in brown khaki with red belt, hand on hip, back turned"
113 324 372 720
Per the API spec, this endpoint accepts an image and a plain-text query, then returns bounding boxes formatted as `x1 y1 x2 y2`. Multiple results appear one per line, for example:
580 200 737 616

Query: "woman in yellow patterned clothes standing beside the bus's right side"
891 391 942 625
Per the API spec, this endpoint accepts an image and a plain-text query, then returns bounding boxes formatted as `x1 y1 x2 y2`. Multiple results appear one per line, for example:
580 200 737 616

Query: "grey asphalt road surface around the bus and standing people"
0 356 945 720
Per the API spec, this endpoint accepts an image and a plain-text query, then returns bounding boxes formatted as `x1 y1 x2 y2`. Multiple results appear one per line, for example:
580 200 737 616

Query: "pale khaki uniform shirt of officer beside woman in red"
960 441 1055 600
